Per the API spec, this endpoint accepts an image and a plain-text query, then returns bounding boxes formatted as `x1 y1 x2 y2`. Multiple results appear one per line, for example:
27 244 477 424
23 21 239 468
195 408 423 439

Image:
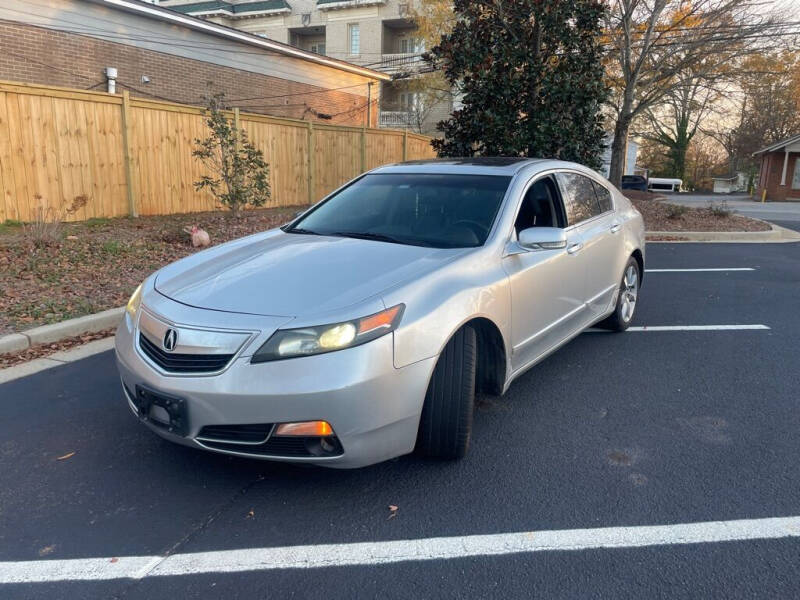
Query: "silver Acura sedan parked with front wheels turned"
116 158 645 468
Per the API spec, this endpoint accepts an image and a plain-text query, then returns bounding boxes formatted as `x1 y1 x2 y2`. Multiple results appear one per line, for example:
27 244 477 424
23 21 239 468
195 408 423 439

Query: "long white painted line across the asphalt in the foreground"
0 517 800 584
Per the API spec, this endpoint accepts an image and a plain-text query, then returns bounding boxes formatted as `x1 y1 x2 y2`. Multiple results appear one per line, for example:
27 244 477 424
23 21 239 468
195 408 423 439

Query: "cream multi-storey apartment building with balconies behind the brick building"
158 0 453 134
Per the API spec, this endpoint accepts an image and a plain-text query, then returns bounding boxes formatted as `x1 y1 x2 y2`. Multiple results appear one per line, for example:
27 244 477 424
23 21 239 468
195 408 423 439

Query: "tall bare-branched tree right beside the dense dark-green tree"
606 0 775 184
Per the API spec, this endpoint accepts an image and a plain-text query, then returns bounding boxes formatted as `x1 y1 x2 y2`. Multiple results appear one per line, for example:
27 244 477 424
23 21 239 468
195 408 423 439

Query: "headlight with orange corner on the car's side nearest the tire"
250 304 405 363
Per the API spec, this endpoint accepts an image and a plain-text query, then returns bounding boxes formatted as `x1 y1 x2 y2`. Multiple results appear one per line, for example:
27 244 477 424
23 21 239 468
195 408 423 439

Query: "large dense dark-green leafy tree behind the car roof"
430 0 607 166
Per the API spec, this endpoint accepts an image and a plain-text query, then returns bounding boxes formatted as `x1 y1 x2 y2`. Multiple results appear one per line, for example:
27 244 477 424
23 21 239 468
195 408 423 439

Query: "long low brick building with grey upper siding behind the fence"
0 0 389 126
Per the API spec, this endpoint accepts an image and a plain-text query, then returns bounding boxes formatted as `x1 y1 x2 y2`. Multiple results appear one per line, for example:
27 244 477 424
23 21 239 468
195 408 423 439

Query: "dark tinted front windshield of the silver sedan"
286 173 511 248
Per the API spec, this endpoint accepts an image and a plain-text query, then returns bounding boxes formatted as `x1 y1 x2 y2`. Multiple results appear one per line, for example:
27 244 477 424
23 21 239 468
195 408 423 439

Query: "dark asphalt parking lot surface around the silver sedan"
0 244 800 599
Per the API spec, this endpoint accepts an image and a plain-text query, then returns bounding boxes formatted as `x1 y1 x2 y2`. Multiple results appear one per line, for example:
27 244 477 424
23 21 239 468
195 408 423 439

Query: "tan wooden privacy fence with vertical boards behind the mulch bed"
0 82 434 222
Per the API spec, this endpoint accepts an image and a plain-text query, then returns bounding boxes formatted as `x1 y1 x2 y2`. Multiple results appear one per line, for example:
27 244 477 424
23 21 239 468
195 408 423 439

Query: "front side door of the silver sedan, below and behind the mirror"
503 175 587 371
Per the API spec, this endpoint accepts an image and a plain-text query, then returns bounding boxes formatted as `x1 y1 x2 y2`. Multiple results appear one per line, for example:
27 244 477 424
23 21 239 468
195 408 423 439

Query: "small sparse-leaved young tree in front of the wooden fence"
192 94 270 217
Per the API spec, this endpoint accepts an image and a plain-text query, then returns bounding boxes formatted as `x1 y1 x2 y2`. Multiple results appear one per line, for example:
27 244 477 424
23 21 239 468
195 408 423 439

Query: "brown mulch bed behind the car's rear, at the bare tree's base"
625 190 770 232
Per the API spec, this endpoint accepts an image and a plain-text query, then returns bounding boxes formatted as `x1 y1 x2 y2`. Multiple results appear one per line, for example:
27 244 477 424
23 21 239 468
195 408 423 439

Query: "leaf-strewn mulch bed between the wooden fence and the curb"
0 207 298 335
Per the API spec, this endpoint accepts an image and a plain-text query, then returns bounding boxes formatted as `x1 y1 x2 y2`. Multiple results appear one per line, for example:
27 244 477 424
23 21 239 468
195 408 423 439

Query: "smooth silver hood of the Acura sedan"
155 230 465 317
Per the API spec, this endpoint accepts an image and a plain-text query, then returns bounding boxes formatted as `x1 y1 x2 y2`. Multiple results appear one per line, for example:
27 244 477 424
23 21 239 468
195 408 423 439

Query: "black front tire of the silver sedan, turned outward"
417 327 477 459
